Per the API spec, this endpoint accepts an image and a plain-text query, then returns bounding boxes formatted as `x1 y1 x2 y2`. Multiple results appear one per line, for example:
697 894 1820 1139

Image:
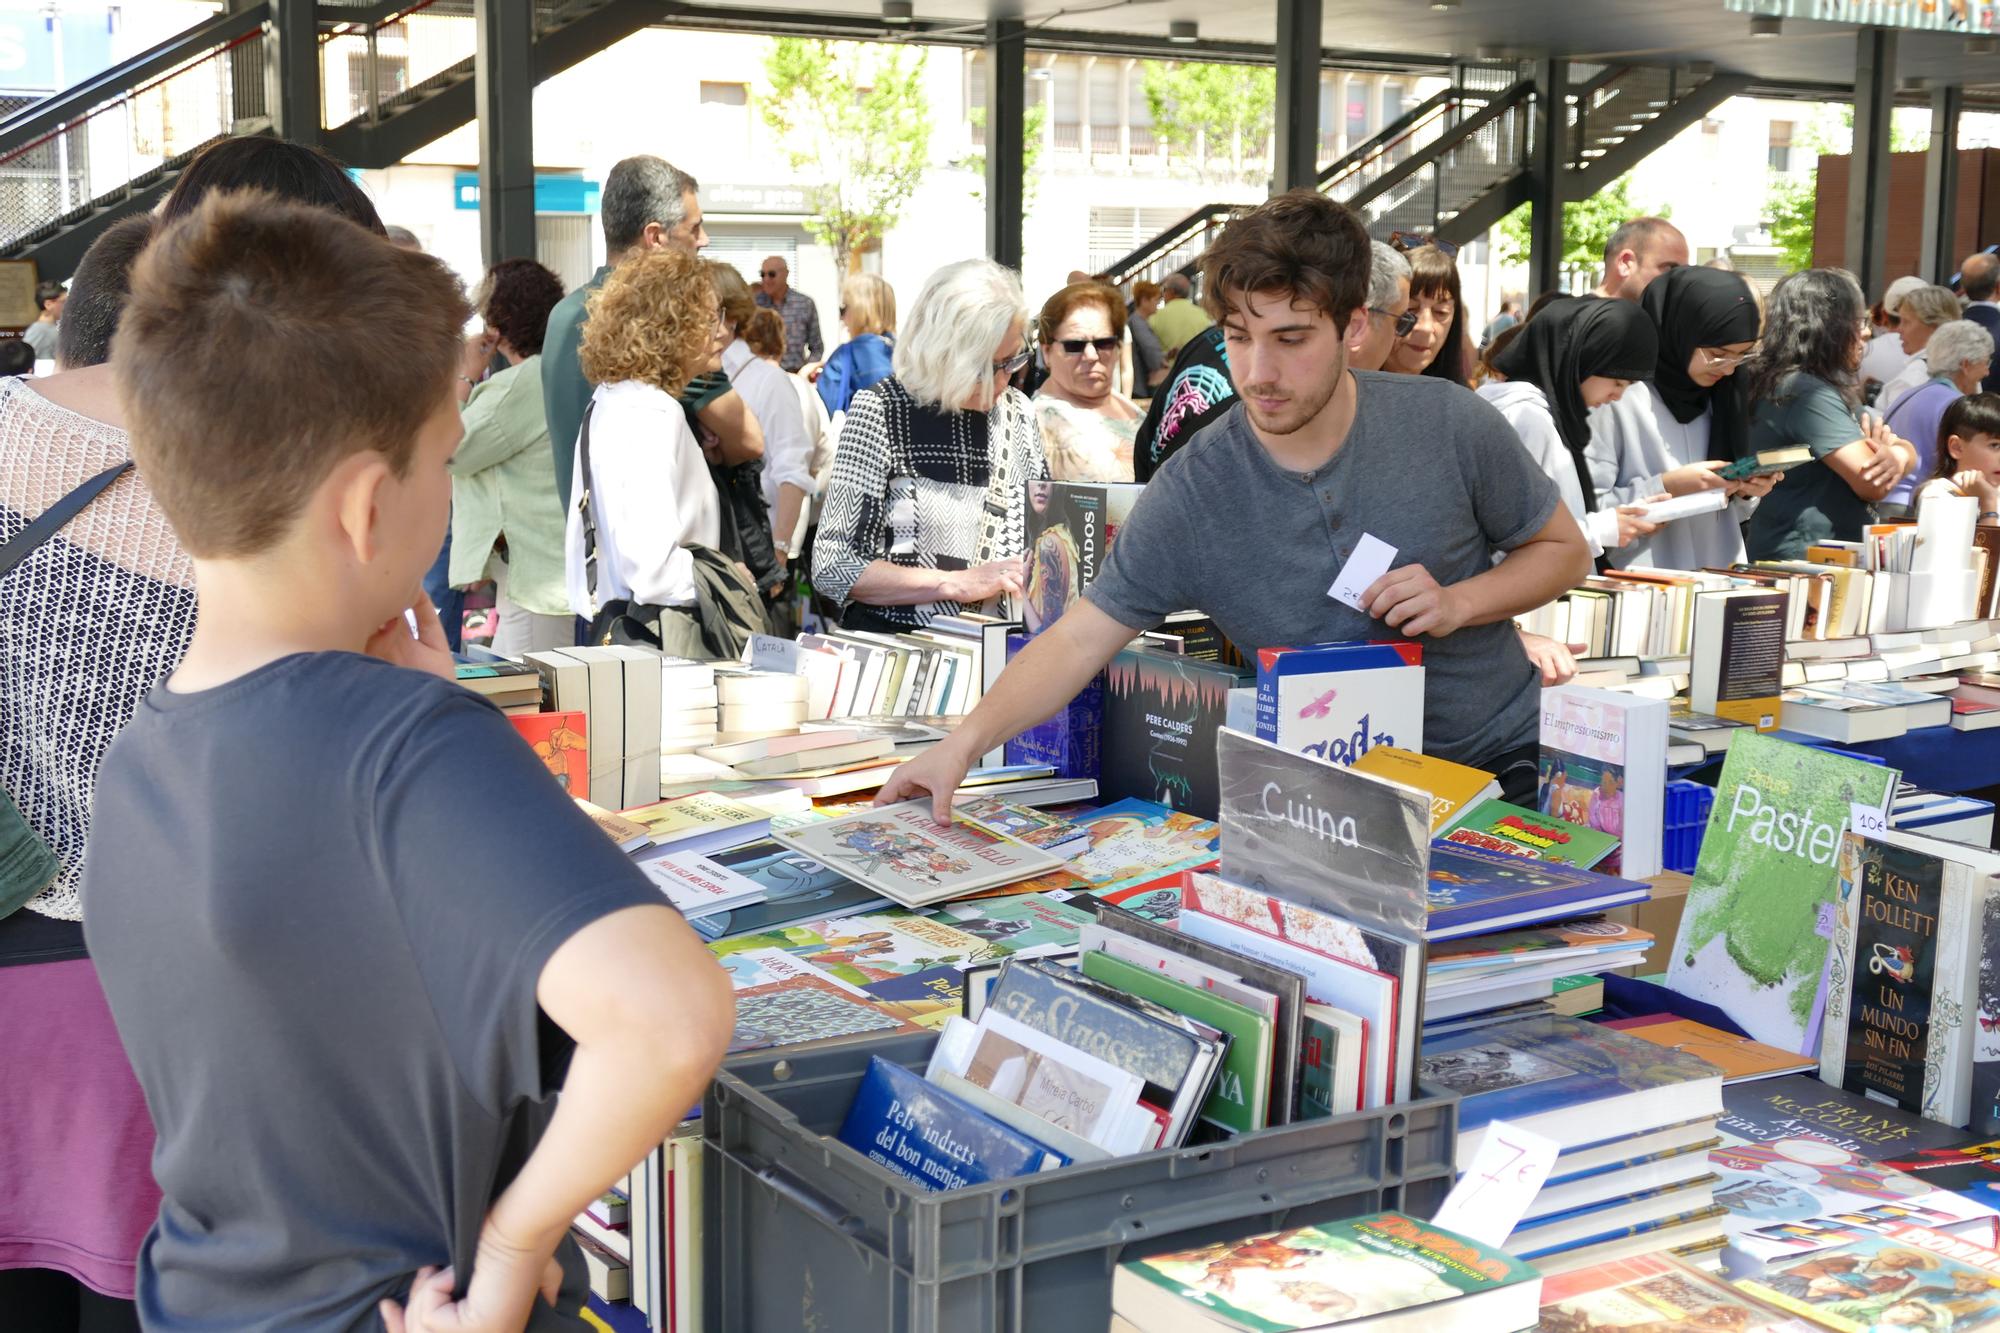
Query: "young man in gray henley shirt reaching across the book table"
878 190 1590 821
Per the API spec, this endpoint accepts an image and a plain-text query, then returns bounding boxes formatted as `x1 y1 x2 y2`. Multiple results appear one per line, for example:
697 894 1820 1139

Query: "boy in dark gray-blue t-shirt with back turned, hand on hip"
84 194 732 1333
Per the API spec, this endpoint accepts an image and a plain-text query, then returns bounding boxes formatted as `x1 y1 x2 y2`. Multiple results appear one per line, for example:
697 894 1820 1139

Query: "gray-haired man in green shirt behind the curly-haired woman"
542 154 716 508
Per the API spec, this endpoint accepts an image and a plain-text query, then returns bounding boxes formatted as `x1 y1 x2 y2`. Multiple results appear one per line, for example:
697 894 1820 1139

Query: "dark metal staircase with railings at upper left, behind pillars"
0 0 666 278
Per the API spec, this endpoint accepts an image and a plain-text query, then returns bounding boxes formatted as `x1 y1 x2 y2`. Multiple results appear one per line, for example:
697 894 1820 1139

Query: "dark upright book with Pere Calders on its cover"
1098 648 1242 819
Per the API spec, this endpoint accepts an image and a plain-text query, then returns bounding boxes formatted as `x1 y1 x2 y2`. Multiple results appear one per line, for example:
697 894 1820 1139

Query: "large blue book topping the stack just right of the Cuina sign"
1424 841 1652 941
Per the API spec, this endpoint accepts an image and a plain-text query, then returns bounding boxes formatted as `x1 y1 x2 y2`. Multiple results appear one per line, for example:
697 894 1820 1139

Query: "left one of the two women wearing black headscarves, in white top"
1478 296 1660 554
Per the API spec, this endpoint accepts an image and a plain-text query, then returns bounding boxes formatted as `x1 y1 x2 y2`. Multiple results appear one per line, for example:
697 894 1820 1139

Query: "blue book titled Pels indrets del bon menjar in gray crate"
840 1055 1070 1189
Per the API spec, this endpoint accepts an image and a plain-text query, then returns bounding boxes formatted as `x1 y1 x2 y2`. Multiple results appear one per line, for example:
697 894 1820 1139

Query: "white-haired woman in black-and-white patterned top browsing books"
812 260 1048 632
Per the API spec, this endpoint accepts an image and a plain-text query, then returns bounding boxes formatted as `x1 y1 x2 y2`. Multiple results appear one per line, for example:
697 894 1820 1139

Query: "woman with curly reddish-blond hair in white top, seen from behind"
564 248 722 618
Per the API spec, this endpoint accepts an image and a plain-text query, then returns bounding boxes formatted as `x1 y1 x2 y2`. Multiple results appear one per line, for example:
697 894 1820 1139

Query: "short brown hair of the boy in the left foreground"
112 192 472 558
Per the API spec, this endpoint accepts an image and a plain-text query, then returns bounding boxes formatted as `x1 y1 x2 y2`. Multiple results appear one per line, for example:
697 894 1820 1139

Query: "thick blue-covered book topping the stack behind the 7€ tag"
1418 1015 1722 1169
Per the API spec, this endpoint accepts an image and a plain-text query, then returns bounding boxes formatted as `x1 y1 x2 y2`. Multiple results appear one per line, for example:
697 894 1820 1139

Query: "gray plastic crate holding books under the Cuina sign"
702 1033 1458 1333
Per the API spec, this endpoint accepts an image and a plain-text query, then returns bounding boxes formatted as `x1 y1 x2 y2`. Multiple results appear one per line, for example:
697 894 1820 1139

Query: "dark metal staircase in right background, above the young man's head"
1106 66 1748 282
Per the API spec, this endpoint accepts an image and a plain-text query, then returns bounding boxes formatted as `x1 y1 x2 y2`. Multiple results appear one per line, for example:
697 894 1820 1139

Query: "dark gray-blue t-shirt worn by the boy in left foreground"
84 652 662 1333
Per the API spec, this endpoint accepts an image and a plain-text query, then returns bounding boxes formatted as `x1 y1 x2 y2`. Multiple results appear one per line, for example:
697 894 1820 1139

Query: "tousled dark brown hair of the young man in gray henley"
1202 190 1374 328
